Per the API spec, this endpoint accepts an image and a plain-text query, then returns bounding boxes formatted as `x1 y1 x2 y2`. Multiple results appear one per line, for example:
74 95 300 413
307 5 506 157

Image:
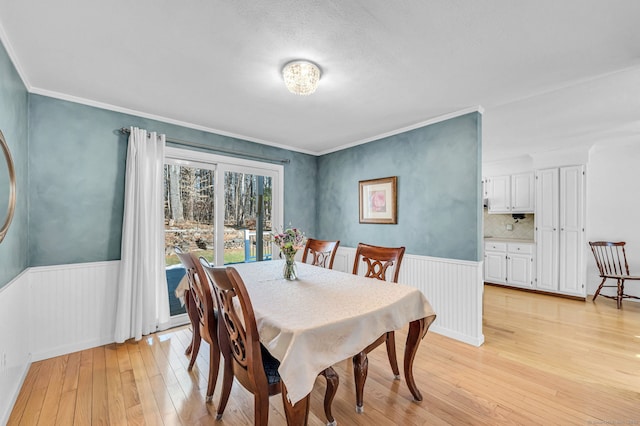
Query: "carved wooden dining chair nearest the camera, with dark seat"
205 267 339 426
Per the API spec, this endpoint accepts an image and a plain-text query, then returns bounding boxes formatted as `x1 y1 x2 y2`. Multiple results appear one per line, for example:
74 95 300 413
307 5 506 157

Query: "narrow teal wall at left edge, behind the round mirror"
0 40 29 288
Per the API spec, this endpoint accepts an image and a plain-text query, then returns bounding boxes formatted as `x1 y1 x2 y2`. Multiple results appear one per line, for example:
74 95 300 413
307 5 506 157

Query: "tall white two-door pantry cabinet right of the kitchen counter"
535 166 586 296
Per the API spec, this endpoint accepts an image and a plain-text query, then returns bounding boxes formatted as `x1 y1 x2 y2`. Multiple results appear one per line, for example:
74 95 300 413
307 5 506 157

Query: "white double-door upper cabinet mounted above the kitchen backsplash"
485 173 535 213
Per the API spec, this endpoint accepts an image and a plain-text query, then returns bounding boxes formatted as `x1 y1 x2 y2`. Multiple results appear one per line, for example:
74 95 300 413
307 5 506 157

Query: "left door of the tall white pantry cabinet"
535 169 559 291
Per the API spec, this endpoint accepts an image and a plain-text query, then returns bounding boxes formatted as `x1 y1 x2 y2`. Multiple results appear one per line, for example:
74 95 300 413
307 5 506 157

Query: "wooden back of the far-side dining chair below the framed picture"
353 243 405 283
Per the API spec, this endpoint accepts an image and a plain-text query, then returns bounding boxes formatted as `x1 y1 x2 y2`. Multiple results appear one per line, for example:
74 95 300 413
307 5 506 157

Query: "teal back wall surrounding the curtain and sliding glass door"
29 95 317 266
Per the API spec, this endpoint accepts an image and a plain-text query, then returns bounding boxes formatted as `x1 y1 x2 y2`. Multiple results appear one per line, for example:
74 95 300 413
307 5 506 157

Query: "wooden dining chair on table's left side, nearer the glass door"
176 250 220 402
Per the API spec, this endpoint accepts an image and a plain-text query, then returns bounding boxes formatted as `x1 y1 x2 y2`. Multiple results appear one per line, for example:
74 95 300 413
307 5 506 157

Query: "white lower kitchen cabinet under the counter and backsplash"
484 241 534 288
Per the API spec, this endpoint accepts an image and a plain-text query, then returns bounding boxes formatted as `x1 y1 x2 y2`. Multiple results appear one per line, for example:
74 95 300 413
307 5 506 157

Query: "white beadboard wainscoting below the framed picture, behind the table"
333 247 484 346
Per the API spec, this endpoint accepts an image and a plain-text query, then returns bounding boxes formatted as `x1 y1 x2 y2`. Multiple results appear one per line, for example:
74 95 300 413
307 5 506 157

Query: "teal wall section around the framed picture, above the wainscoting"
317 113 482 261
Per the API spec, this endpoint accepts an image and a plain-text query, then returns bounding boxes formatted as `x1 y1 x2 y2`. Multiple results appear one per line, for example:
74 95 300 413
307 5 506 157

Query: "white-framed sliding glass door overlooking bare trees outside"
164 148 283 316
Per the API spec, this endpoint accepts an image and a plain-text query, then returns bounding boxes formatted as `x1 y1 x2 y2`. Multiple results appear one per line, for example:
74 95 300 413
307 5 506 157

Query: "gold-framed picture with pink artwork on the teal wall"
360 176 398 224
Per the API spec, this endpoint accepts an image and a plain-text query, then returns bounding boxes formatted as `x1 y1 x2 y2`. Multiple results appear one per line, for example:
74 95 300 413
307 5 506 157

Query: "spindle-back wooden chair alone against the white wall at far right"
589 241 640 309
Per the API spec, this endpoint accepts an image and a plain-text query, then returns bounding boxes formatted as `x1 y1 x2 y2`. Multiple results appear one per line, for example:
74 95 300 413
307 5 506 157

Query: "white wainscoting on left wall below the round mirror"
0 271 31 425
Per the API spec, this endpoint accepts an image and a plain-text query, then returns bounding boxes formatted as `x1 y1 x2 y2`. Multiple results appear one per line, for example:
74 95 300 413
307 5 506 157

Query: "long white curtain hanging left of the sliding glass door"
115 127 169 343
